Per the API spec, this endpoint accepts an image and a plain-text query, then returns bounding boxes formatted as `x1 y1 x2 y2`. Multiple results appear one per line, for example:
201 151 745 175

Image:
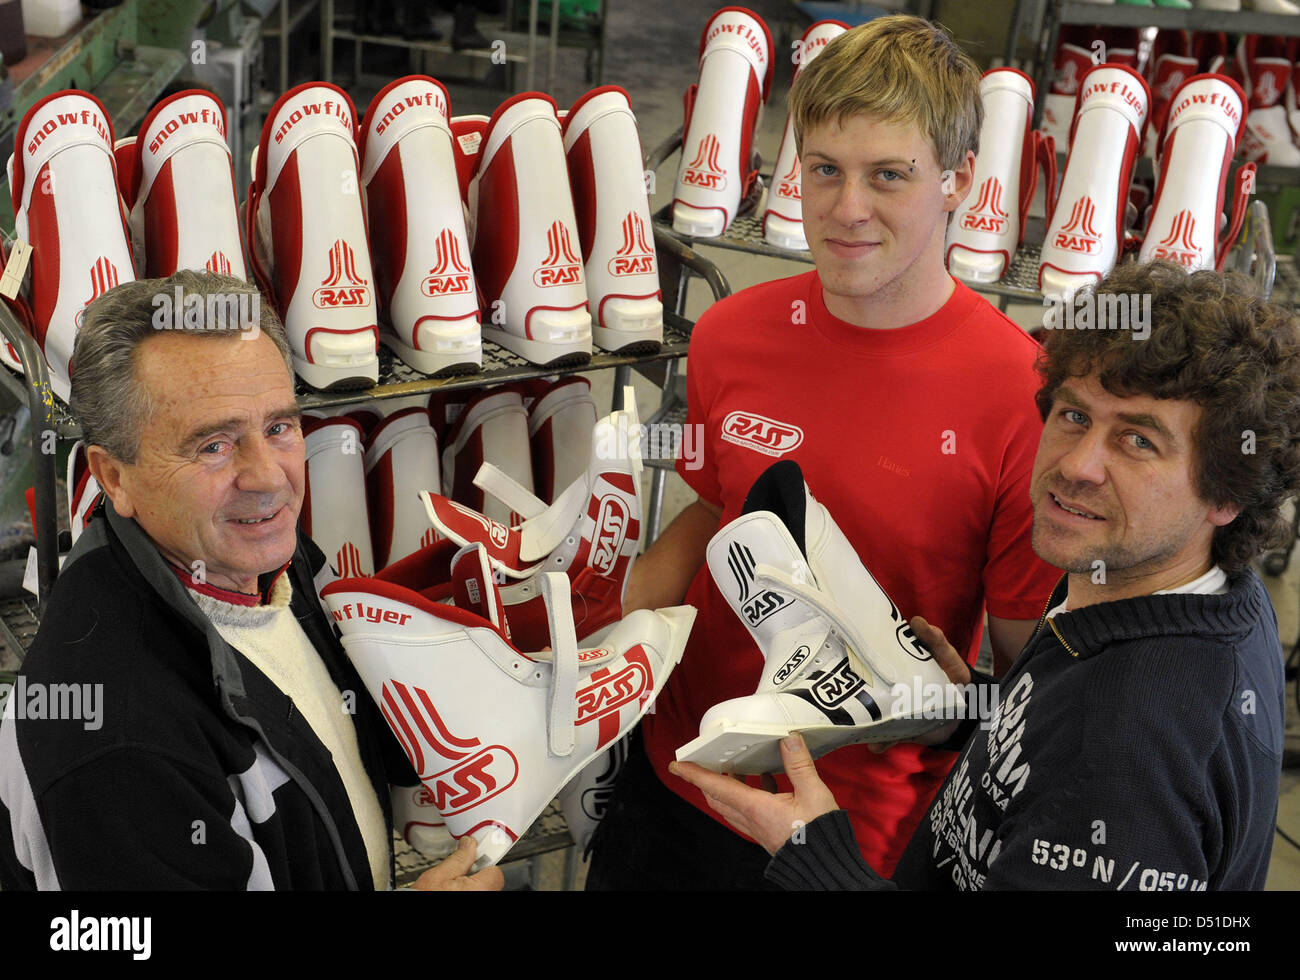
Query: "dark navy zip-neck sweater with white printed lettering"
767 571 1286 890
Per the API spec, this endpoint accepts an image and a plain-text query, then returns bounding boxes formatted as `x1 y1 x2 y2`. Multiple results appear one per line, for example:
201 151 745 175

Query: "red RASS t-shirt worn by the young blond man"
644 272 1061 875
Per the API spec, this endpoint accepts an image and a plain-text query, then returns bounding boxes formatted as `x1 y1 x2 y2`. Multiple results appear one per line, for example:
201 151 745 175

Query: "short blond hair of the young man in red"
789 14 984 170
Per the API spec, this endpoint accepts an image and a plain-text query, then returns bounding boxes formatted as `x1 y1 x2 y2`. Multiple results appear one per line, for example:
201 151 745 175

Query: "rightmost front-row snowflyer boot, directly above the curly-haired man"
1138 75 1255 269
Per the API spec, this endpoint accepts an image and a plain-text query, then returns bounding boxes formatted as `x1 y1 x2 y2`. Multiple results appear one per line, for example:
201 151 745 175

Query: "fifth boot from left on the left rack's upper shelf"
469 92 592 367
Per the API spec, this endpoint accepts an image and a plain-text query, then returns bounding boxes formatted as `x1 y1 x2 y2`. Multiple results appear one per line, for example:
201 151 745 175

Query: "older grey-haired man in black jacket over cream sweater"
0 272 502 890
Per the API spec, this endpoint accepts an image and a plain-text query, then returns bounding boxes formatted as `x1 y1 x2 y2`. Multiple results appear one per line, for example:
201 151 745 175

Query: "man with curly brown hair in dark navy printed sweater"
673 264 1300 890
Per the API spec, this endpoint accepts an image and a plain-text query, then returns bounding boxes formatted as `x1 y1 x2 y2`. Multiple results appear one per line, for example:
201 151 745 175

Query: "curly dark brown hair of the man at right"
1036 263 1300 572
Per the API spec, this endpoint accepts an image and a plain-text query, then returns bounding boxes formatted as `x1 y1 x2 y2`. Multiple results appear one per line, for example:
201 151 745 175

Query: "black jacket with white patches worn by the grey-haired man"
0 503 416 892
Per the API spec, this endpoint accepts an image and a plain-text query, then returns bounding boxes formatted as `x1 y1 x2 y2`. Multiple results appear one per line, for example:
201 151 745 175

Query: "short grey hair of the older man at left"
69 269 294 463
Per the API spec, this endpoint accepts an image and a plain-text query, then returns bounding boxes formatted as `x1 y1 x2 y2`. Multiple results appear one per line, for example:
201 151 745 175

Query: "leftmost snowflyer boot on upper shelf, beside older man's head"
8 91 135 400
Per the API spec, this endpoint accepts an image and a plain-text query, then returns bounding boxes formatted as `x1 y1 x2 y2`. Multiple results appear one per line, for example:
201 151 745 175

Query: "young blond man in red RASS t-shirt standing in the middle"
588 16 1057 889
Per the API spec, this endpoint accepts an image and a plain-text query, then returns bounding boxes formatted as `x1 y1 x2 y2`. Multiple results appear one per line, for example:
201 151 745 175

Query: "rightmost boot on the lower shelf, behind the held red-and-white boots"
528 377 595 504
